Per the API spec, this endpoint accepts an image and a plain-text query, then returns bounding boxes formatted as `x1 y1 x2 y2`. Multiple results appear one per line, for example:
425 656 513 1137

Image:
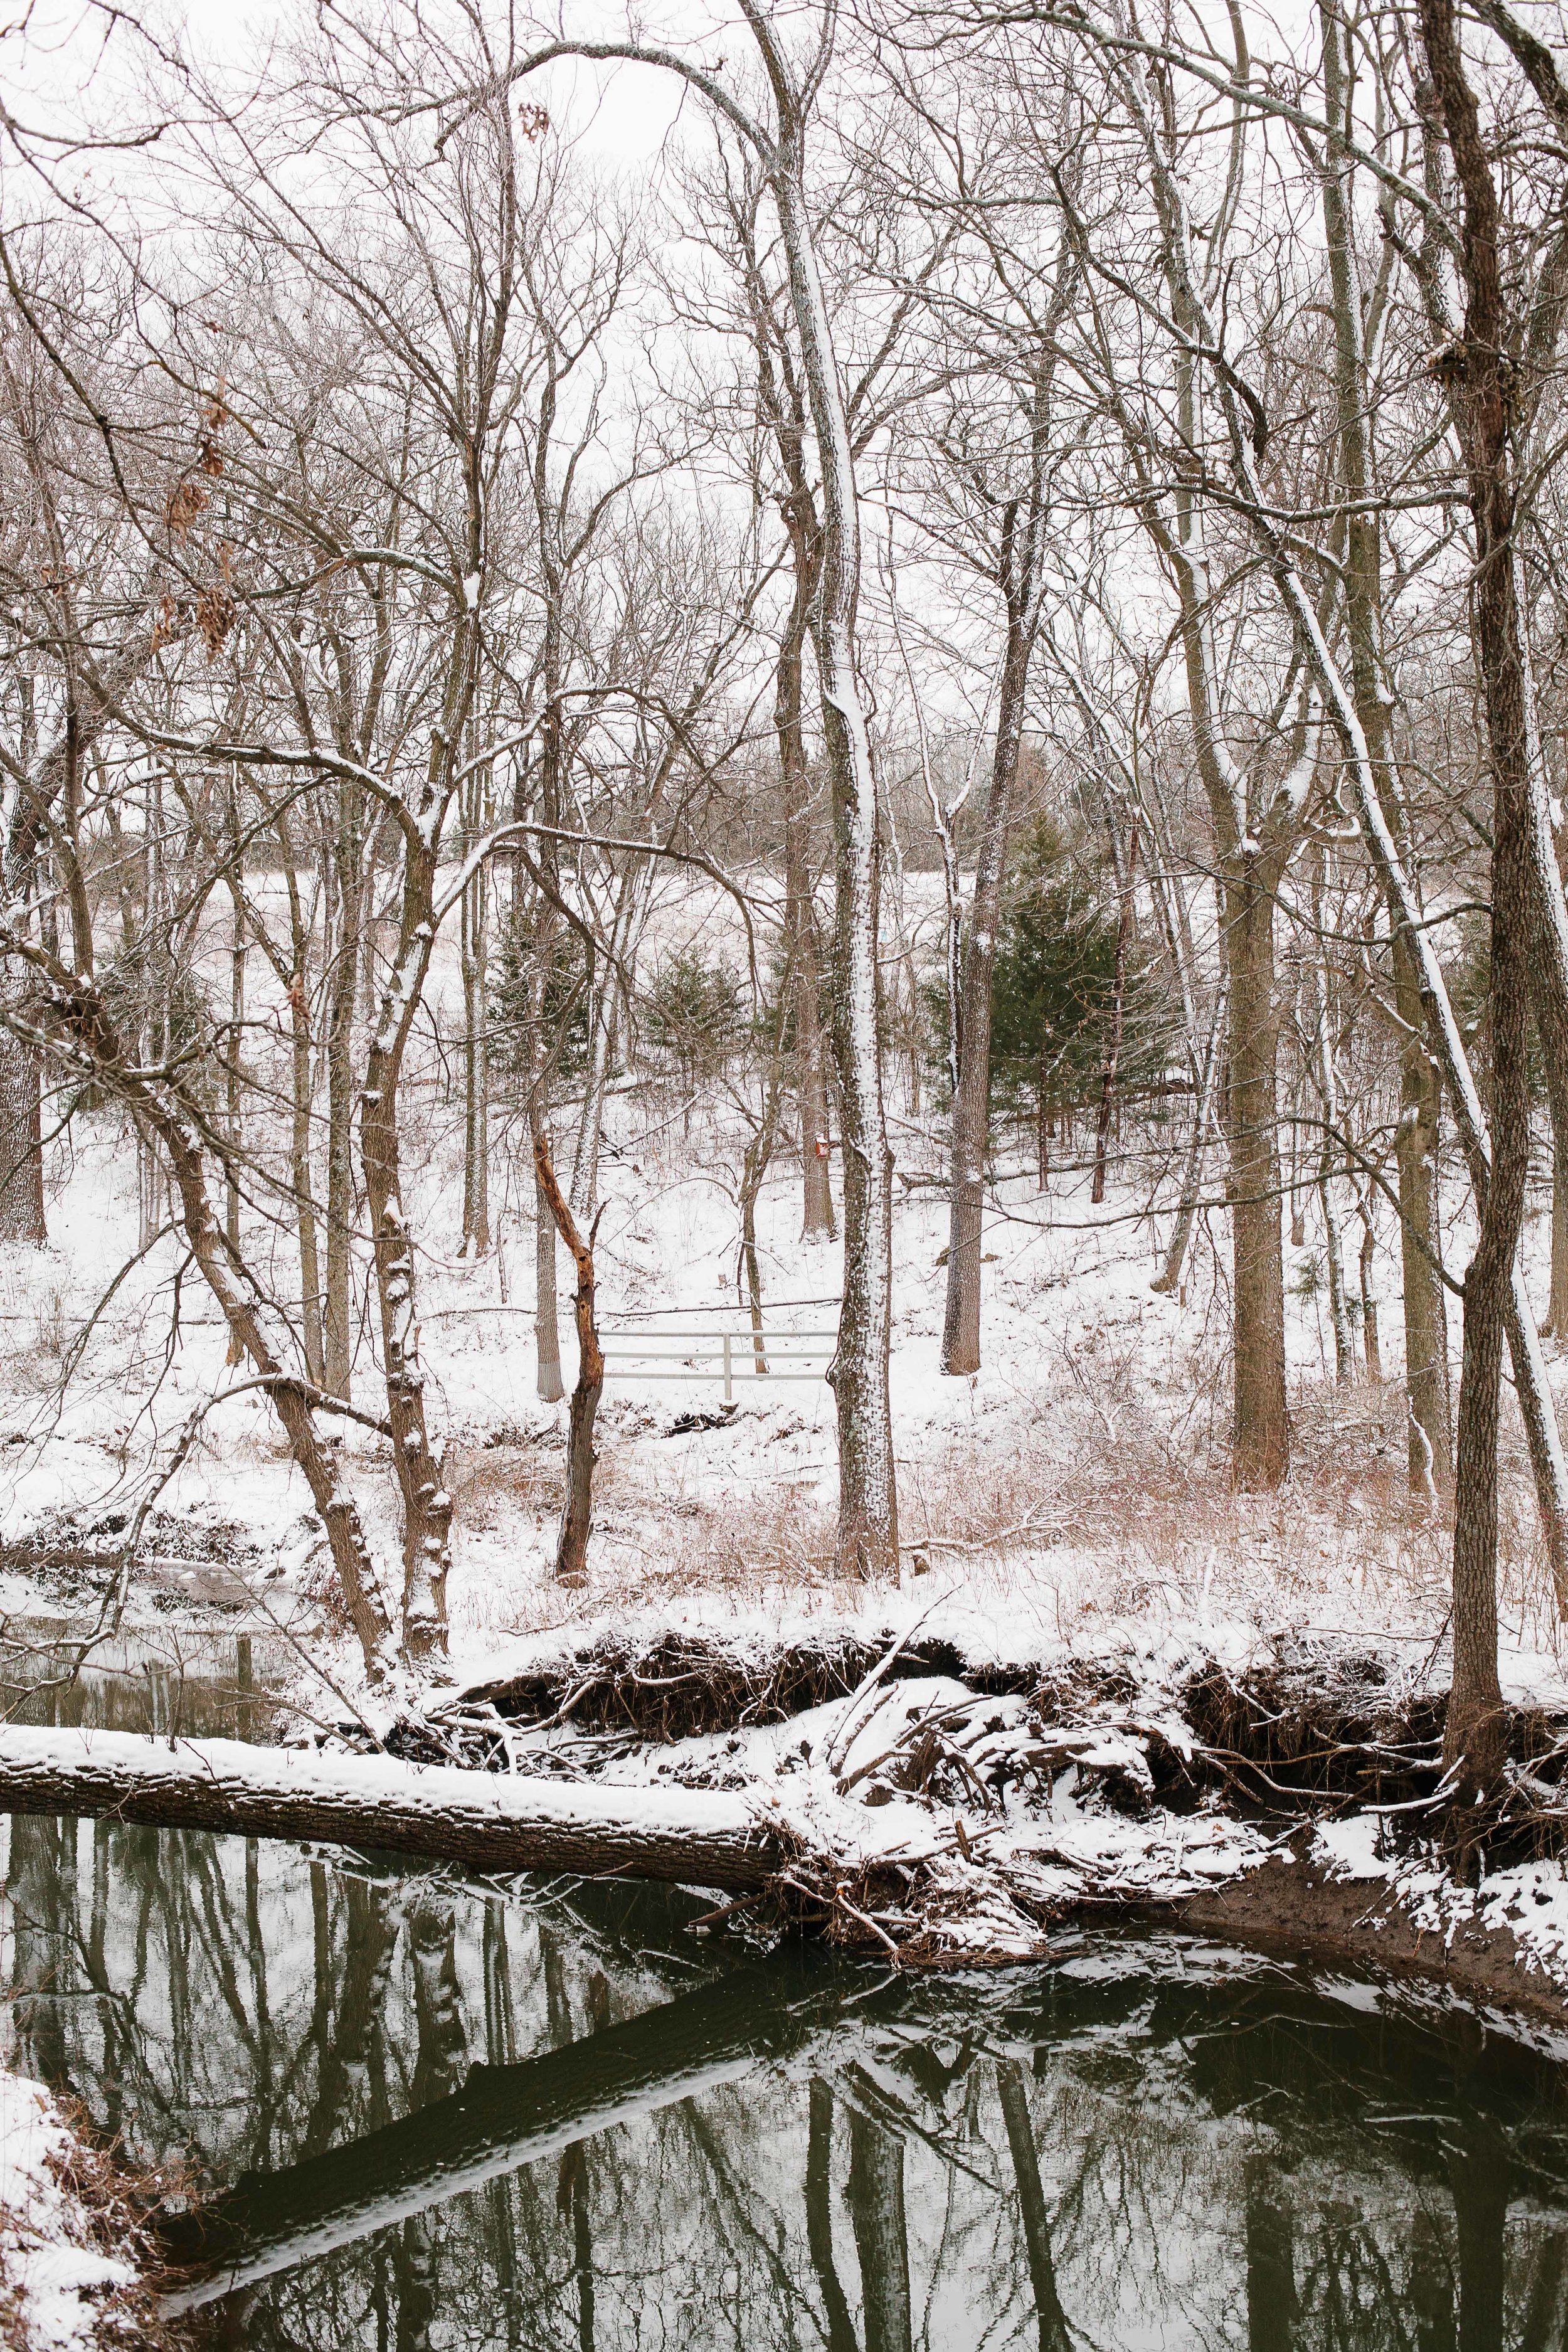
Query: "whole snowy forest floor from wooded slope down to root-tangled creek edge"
0 1117 1568 2016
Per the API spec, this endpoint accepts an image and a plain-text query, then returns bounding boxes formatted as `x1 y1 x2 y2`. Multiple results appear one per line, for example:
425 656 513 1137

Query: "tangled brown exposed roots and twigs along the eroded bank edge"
420 1633 1568 1966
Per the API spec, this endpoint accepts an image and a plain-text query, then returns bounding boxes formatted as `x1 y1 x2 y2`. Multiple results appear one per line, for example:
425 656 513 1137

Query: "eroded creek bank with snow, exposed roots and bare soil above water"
371 1630 1568 2018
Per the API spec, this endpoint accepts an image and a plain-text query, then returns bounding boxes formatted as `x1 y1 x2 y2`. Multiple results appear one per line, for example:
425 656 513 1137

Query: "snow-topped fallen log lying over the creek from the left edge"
0 1724 788 1891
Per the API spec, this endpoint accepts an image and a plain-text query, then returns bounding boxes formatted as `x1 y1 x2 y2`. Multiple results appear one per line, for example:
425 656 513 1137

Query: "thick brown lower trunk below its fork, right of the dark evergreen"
1225 859 1291 1486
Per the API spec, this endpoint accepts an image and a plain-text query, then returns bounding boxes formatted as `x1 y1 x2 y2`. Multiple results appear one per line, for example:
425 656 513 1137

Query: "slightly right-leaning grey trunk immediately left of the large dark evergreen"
943 612 1030 1374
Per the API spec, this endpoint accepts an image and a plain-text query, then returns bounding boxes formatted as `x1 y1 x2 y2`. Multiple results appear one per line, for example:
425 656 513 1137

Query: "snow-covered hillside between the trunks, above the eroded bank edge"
0 1077 1556 1675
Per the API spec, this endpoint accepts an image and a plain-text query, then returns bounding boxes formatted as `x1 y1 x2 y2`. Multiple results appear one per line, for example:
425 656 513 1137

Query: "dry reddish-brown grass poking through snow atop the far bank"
514 1350 1556 1649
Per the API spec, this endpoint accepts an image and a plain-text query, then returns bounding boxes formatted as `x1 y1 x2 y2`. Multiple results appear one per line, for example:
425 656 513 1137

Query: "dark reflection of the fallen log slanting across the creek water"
157 1959 837 2314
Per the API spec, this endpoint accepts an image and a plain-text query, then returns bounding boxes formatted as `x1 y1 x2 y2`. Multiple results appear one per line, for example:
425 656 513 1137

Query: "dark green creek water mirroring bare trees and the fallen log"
0 1646 1568 2352
